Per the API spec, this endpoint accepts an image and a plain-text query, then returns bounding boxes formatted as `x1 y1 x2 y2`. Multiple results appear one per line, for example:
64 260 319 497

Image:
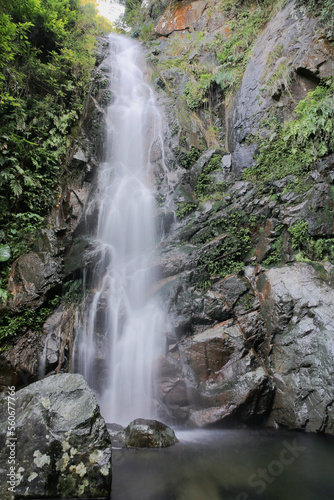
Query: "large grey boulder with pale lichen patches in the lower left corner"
0 374 111 499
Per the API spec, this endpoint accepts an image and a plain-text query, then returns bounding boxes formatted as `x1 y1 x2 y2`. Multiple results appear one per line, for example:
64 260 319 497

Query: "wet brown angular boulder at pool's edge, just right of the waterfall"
179 320 274 427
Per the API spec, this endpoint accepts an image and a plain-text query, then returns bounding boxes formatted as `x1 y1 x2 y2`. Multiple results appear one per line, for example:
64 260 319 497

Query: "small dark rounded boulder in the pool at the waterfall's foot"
125 418 178 448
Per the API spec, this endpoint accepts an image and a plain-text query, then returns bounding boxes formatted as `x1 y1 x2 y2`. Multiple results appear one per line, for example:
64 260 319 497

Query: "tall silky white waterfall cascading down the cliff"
74 35 165 424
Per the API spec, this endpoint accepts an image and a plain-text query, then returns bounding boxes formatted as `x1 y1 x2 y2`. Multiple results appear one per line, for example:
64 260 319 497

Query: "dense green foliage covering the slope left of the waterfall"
0 0 110 298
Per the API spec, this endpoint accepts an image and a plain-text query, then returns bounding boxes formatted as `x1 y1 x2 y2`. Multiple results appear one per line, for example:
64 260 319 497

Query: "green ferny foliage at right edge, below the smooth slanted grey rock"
244 79 334 182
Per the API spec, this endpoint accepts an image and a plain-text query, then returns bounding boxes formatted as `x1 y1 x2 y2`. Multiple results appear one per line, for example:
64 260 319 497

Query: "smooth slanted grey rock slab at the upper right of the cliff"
228 1 334 175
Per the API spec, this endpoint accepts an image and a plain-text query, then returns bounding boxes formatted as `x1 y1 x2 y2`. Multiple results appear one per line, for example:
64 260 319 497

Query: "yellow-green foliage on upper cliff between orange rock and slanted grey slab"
149 0 277 110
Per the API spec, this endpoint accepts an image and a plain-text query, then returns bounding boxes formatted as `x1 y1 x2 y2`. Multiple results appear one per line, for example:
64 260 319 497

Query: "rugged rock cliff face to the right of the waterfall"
141 2 334 433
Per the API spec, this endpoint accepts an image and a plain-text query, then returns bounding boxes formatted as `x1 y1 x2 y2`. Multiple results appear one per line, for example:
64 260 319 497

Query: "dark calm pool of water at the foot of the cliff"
111 430 334 500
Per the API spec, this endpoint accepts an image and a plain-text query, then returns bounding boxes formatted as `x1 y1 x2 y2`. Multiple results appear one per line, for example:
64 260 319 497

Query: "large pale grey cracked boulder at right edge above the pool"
258 263 334 434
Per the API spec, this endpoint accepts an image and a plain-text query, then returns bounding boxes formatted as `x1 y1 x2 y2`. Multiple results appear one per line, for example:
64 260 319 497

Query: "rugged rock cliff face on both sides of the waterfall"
0 0 334 433
